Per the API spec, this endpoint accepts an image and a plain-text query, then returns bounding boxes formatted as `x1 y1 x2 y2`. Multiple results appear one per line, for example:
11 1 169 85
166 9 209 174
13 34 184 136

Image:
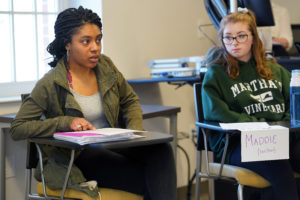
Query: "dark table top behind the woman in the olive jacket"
0 104 181 123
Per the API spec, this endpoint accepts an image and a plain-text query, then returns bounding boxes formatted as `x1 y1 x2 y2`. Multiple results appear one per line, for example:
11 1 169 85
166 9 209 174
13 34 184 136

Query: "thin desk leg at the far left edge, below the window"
0 123 8 200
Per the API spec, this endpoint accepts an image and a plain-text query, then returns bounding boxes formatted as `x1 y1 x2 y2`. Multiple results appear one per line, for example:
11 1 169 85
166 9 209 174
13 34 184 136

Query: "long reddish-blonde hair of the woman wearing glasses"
218 10 273 79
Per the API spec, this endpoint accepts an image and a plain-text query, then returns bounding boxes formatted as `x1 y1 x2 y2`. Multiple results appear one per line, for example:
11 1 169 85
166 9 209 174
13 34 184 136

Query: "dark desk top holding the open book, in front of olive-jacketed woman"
28 132 173 149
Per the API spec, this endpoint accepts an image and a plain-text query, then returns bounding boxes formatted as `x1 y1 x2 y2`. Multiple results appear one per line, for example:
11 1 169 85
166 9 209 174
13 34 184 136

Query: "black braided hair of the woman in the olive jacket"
47 6 102 67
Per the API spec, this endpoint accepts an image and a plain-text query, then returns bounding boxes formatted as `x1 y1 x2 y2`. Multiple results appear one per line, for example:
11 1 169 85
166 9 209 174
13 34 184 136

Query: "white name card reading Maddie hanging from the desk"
241 126 289 162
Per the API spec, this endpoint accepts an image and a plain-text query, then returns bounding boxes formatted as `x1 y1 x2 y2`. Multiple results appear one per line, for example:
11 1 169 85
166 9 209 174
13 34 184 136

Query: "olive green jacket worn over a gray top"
10 55 143 198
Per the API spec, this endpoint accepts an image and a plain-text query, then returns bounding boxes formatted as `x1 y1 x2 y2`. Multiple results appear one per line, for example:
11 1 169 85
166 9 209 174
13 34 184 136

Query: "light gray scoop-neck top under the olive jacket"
71 89 109 129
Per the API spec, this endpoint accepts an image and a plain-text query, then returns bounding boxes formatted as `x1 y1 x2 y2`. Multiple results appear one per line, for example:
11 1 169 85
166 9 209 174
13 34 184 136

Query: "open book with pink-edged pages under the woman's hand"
53 128 143 145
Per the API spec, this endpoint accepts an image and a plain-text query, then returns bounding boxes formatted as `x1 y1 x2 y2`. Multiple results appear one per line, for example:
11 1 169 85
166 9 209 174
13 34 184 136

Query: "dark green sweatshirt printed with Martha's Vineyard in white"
202 52 291 161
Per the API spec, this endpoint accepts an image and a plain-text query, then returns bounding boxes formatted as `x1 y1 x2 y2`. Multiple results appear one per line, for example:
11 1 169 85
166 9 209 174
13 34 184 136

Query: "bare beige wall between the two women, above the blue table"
102 0 213 79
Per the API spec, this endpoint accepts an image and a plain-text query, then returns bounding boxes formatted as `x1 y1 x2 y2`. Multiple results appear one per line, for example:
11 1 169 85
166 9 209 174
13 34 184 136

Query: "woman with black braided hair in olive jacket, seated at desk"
10 6 176 200
